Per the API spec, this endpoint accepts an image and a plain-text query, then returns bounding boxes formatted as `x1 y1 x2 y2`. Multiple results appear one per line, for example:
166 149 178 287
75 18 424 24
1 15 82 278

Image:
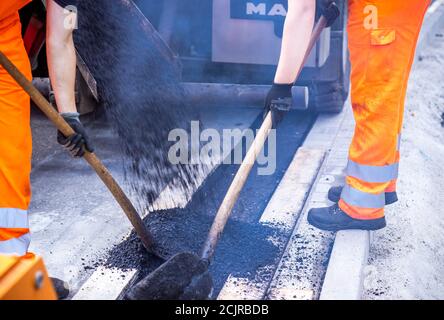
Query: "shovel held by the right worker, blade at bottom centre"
126 3 340 300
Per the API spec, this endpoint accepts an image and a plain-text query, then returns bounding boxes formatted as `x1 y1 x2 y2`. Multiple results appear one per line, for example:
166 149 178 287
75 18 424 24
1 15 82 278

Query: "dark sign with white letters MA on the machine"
230 0 288 20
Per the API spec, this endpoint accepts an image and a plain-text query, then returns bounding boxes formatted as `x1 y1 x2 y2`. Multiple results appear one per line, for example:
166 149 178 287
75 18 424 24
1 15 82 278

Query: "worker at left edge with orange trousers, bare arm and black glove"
0 0 92 295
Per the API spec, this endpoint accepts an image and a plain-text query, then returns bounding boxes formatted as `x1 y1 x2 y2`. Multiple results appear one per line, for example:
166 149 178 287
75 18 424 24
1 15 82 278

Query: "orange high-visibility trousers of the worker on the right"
339 0 430 220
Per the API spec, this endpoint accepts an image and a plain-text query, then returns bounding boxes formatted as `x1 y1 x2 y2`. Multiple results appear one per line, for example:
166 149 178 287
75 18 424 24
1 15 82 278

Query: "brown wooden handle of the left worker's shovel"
0 51 155 253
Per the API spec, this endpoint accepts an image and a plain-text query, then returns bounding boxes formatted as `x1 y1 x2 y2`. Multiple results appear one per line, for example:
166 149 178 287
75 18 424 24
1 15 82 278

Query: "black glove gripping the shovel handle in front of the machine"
264 83 293 129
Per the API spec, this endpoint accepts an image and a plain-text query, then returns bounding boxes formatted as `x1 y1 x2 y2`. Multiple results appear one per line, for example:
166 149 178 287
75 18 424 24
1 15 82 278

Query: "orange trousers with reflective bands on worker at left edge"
0 0 32 255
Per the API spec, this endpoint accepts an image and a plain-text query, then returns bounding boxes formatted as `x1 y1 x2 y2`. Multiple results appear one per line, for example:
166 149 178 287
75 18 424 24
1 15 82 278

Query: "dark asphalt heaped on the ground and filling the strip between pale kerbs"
106 112 315 298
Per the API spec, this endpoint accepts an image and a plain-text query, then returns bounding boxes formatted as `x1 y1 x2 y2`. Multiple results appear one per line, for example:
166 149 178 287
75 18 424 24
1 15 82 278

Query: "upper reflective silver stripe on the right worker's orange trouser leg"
345 160 399 183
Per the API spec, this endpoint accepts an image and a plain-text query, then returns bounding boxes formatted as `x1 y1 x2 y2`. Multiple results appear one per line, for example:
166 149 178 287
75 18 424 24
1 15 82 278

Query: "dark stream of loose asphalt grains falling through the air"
75 0 206 211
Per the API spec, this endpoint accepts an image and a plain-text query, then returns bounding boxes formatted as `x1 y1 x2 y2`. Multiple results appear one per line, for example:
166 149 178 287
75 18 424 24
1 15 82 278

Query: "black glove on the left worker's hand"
57 112 94 157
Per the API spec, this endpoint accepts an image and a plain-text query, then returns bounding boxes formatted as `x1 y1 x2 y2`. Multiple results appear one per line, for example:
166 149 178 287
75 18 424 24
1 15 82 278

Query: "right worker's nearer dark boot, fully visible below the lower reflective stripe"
307 204 386 231
